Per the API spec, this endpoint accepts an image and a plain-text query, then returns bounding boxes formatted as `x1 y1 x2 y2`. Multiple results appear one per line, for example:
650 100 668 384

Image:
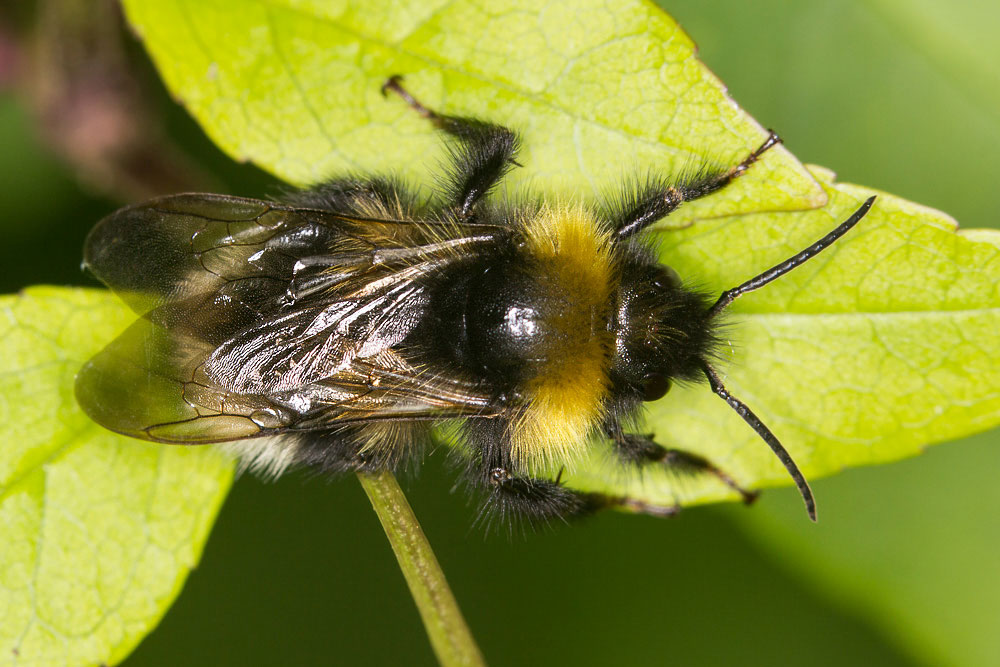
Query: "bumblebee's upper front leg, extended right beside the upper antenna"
611 132 781 238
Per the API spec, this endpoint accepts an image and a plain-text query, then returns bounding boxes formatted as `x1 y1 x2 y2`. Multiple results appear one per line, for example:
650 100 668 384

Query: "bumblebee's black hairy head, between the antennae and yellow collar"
612 263 717 401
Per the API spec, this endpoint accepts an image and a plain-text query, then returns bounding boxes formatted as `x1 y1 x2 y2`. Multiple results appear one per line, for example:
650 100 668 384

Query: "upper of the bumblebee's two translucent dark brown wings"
84 194 501 314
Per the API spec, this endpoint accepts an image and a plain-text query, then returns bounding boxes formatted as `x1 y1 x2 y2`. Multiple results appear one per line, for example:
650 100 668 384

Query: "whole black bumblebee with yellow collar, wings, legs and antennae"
76 77 874 521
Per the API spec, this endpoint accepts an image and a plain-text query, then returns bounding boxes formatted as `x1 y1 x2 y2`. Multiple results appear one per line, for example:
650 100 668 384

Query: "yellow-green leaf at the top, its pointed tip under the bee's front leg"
117 0 823 218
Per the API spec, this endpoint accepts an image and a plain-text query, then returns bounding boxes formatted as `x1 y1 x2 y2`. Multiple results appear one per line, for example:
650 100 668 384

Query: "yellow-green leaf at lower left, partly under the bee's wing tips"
0 287 232 665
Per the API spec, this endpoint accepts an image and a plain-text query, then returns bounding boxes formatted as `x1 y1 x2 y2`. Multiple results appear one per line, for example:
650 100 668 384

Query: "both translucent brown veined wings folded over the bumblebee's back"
77 195 501 443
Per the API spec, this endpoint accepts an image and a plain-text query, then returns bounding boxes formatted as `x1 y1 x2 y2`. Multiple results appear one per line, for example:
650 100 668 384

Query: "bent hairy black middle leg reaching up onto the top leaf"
382 76 520 218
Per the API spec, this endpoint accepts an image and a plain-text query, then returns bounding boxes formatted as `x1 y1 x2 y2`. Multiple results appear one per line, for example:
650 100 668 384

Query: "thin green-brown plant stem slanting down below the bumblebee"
358 472 486 667
